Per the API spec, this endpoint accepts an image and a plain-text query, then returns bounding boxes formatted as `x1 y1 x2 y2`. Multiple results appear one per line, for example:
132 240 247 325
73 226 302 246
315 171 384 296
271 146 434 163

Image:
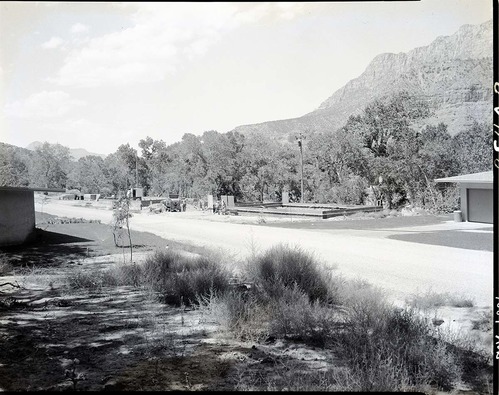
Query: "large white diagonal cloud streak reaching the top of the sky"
51 3 301 87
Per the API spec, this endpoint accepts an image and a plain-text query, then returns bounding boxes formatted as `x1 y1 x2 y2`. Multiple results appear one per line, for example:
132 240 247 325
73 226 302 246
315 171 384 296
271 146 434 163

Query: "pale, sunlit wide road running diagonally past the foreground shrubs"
36 202 493 306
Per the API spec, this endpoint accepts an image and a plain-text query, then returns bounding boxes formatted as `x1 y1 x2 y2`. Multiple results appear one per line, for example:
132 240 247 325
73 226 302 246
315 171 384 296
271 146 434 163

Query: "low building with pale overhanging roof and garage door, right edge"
435 171 494 224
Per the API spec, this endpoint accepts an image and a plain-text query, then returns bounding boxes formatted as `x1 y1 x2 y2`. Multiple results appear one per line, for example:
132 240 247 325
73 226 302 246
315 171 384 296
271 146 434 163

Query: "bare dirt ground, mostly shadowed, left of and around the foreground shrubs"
0 209 491 393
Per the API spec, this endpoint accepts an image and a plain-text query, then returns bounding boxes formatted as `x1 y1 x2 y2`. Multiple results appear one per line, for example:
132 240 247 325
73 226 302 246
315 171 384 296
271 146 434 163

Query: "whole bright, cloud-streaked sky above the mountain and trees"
0 0 492 154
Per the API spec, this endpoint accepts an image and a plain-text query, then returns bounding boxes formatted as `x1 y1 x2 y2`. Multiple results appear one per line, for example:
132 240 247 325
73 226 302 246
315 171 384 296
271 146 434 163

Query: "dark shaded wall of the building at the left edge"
0 188 35 246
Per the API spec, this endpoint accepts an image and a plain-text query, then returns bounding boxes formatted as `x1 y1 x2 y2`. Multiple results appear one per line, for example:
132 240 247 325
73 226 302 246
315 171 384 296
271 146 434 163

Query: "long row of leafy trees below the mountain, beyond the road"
0 92 493 209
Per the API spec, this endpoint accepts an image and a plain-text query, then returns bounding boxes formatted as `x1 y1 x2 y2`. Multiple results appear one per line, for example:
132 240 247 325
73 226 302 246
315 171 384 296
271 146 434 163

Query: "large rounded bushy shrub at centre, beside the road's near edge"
201 245 341 345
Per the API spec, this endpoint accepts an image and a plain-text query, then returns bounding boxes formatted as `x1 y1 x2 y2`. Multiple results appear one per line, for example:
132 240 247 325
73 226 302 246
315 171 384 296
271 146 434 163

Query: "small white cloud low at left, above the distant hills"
5 91 85 118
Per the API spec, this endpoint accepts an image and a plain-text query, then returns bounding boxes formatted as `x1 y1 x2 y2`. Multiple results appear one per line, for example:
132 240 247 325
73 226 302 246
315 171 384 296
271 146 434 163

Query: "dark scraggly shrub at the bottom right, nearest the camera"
337 303 461 391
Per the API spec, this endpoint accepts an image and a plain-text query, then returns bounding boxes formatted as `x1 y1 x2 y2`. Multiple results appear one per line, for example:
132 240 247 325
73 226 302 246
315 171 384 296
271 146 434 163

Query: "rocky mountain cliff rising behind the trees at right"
234 20 493 138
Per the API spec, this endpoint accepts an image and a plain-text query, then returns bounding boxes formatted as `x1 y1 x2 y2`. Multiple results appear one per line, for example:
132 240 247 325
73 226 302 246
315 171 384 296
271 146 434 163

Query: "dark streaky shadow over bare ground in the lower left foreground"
0 287 225 391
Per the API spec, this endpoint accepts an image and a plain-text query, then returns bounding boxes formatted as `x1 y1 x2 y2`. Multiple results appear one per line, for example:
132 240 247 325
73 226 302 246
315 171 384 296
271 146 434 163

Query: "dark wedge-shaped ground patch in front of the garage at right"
388 228 494 251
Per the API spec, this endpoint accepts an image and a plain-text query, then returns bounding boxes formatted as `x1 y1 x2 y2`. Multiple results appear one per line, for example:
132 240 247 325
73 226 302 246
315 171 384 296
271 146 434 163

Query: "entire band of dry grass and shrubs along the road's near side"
59 245 487 392
